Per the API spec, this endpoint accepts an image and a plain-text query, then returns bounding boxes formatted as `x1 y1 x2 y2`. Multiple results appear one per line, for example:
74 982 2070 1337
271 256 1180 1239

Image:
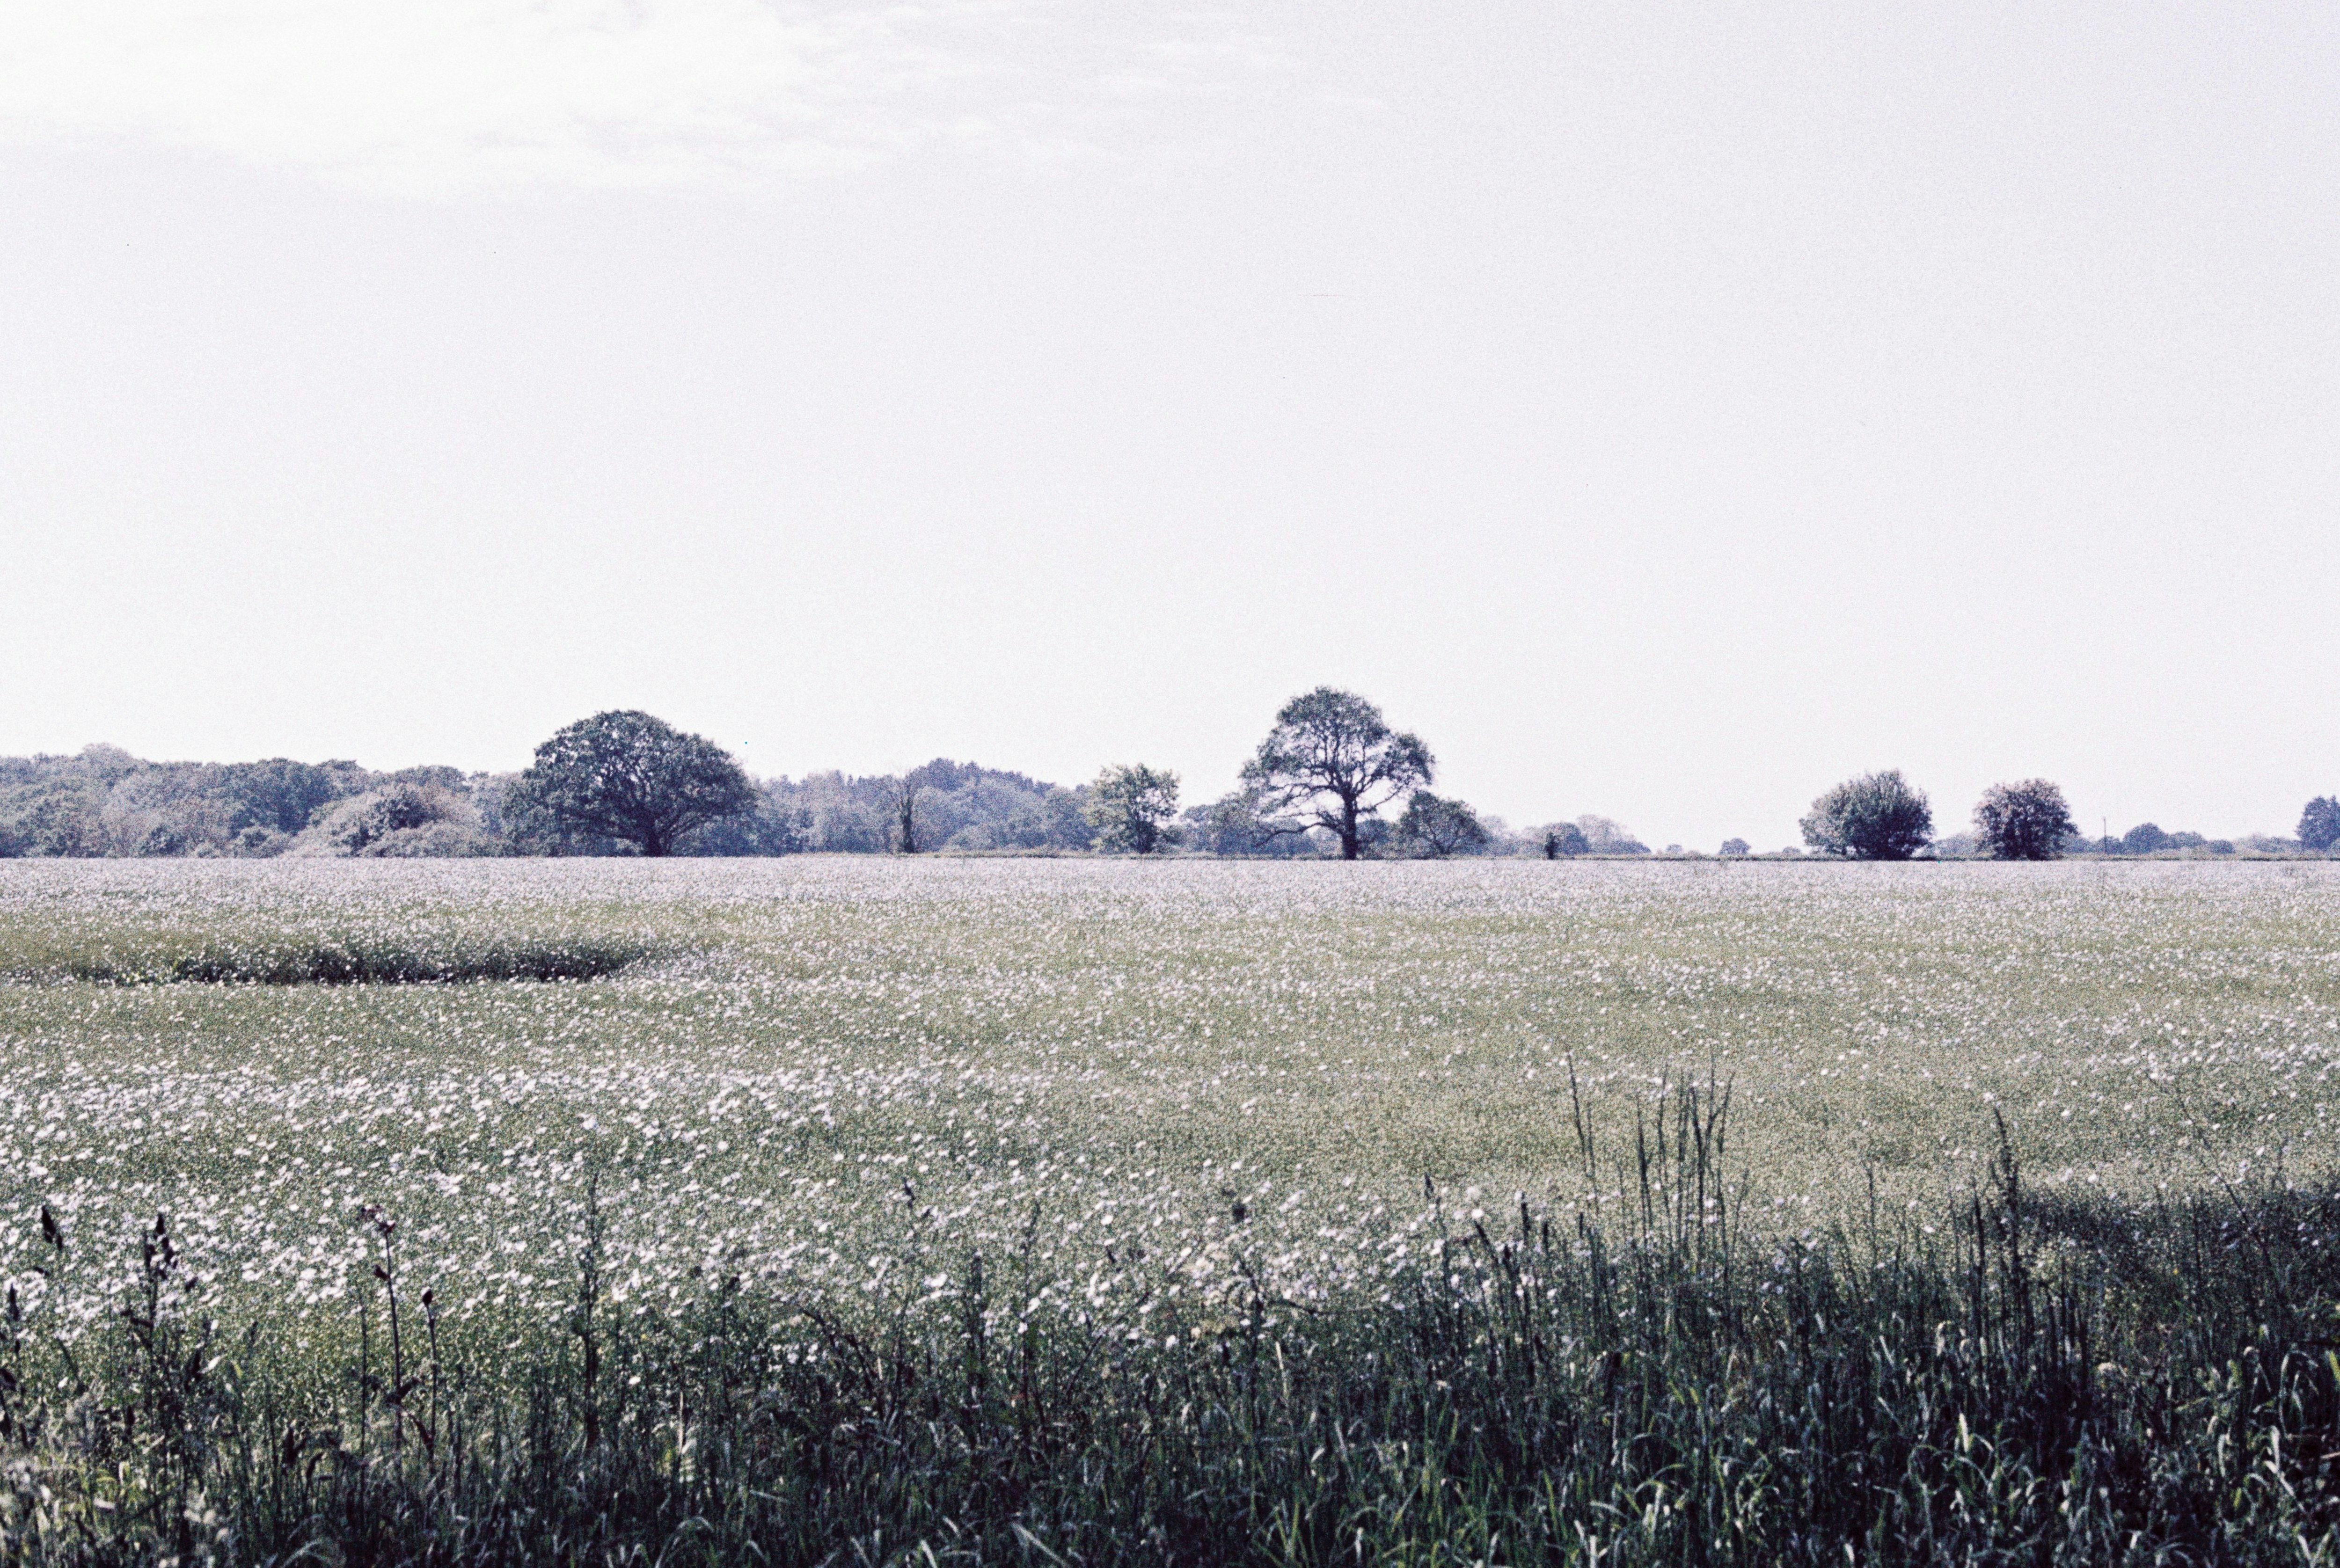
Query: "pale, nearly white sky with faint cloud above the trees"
0 0 2340 850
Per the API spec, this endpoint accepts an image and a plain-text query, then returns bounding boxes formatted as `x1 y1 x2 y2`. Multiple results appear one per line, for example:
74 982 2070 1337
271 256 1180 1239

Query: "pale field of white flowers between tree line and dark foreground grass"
0 859 2340 1561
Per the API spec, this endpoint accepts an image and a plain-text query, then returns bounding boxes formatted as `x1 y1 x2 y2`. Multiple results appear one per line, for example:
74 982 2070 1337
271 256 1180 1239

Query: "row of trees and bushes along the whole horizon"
0 686 2340 859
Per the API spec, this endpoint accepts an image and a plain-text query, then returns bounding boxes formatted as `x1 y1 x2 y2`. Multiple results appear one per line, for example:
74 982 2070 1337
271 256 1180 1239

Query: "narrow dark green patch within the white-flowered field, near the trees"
21 934 658 985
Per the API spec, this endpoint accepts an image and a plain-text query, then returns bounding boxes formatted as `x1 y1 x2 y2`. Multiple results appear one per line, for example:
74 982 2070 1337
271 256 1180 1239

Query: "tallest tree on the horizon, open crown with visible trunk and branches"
1243 686 1437 861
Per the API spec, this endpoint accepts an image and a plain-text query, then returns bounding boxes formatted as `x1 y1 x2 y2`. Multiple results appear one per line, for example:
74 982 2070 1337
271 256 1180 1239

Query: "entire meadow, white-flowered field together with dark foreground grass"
0 857 2340 1561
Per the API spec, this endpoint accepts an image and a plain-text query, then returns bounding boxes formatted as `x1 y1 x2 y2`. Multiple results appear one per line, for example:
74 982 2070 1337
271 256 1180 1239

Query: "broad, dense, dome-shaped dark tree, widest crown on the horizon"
512 709 756 854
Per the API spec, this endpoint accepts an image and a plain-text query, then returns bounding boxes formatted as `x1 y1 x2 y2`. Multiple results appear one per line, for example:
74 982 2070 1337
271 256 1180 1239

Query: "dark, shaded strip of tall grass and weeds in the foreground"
0 1104 2340 1566
